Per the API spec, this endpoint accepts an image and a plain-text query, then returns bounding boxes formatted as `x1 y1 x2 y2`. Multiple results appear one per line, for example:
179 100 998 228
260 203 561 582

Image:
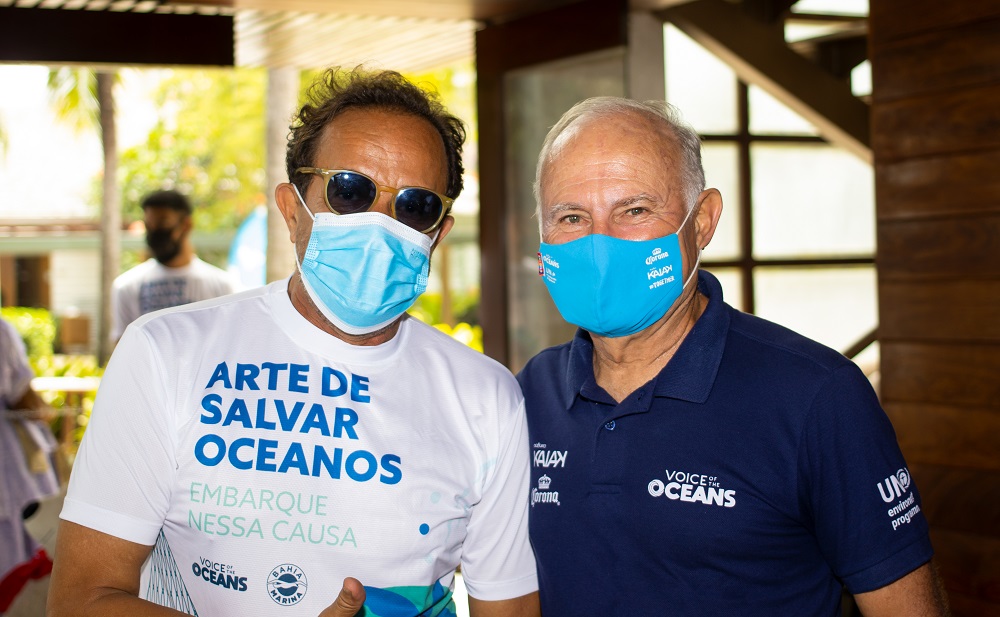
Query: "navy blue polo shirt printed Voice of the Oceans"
518 272 932 617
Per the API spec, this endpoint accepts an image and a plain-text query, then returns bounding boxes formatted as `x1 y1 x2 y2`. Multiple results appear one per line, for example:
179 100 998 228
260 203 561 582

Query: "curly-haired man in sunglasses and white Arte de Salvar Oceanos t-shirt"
49 70 539 617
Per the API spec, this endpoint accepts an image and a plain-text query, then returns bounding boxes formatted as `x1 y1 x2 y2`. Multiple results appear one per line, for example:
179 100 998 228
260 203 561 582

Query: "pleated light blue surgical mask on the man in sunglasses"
293 185 437 335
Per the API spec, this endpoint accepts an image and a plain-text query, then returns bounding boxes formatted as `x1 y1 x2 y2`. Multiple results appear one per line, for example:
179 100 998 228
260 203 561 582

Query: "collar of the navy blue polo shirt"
563 270 729 409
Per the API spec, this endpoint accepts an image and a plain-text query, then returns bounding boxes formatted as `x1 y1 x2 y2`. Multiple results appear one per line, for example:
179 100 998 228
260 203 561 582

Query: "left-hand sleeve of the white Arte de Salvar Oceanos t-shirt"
60 328 177 546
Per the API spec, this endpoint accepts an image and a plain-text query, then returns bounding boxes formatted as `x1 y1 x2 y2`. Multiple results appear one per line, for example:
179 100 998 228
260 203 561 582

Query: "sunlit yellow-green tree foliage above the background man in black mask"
120 69 267 231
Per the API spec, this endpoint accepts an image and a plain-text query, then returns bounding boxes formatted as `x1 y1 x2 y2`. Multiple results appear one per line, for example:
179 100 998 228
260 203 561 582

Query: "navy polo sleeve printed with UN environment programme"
799 364 933 593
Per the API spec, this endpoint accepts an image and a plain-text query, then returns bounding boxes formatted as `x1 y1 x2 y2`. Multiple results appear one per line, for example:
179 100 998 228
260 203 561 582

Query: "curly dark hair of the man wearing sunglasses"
285 67 465 198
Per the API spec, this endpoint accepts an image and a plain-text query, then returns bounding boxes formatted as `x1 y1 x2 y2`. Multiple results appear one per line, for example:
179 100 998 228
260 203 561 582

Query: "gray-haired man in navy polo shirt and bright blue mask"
518 97 947 617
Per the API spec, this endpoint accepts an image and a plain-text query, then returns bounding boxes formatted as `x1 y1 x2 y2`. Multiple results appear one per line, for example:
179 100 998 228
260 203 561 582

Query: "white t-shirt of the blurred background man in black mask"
111 257 237 340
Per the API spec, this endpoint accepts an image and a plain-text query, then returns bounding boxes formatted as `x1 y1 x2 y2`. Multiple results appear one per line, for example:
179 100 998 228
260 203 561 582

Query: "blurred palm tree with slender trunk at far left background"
49 67 122 366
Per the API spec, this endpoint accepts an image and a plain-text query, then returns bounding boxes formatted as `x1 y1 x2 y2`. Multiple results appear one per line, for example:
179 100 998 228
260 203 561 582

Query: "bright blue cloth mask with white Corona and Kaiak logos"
538 208 701 337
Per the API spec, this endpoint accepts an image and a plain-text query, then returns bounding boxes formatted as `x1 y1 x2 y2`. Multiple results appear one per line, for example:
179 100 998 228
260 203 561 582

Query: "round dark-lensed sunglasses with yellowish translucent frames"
295 167 455 233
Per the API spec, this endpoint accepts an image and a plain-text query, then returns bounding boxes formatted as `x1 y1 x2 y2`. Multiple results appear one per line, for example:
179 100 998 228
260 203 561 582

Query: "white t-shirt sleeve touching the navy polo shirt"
462 397 538 600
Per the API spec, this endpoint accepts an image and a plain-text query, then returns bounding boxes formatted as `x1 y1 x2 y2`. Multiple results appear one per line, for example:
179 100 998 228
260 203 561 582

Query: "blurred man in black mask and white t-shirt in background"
111 190 236 341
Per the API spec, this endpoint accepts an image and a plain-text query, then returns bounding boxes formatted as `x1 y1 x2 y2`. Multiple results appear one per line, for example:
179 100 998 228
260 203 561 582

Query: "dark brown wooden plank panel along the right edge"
870 0 1000 617
